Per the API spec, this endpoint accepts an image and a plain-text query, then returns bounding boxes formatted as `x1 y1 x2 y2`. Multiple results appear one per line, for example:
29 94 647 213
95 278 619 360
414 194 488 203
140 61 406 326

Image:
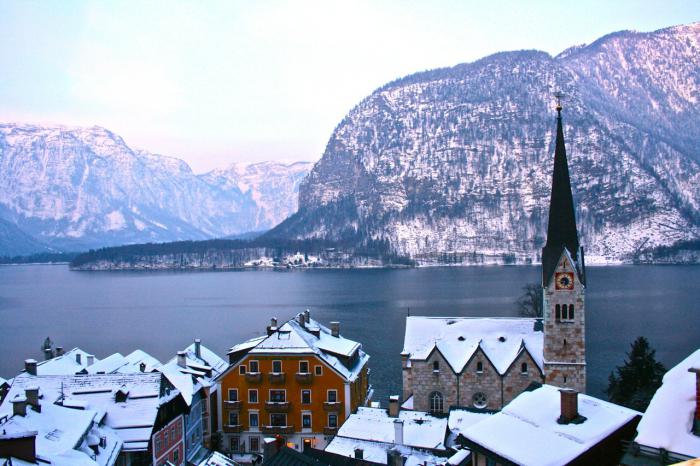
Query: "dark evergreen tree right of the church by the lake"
606 337 666 411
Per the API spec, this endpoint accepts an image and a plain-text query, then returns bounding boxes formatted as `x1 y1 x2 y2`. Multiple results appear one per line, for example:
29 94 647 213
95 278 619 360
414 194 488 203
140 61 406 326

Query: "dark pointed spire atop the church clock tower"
542 100 582 286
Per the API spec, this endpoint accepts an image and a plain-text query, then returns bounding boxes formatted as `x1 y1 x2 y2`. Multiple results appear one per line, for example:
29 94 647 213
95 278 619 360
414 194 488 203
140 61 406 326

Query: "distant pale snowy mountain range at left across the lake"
0 124 310 255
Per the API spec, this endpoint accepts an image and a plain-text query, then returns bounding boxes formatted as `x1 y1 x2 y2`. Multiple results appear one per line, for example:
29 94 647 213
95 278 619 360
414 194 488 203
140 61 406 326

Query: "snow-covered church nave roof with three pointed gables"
402 316 544 374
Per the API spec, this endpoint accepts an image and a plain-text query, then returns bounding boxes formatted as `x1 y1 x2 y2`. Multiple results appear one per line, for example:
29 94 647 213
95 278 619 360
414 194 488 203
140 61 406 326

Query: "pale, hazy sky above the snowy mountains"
0 0 700 173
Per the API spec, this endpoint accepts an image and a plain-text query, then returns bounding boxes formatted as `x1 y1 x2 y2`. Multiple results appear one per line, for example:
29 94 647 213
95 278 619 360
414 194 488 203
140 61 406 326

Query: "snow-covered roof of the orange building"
229 315 369 380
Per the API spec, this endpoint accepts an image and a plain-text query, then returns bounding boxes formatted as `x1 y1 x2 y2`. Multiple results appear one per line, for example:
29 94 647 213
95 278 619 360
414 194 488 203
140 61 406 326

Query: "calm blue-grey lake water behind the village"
0 265 700 400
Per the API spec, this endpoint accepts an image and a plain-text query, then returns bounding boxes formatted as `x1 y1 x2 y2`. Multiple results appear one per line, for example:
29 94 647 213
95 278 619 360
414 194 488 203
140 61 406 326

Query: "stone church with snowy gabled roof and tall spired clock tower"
401 105 586 413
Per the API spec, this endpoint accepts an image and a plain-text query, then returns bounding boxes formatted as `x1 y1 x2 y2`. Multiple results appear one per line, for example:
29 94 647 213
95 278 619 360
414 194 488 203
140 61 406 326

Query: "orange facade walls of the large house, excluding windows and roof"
219 354 368 451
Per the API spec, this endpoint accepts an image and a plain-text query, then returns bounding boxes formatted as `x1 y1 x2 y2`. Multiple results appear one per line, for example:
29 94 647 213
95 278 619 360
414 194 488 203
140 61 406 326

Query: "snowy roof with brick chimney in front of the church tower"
462 385 640 466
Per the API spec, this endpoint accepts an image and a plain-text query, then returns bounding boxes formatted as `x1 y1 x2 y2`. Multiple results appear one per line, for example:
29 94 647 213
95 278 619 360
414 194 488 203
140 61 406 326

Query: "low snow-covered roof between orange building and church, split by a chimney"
338 407 447 450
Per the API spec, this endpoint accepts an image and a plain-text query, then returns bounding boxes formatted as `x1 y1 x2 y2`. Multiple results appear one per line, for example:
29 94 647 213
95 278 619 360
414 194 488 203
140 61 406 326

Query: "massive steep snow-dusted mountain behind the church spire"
270 23 700 263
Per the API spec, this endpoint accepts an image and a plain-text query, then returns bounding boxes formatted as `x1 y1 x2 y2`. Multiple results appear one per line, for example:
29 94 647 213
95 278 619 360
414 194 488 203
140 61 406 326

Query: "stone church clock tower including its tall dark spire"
542 101 586 393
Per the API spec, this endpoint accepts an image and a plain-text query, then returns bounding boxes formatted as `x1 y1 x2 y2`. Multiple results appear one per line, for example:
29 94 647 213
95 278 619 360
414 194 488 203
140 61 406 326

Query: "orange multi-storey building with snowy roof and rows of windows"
217 311 371 453
